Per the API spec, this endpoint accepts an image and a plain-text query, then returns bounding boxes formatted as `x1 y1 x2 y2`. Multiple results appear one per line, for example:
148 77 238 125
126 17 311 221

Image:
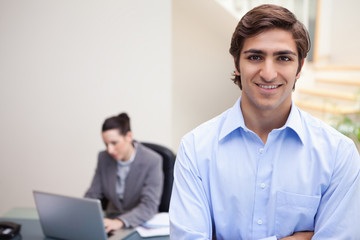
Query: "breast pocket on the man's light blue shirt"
275 191 320 238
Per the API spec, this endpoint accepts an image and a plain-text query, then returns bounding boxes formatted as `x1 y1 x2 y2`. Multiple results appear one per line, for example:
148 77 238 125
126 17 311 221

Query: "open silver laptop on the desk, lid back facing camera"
33 191 107 240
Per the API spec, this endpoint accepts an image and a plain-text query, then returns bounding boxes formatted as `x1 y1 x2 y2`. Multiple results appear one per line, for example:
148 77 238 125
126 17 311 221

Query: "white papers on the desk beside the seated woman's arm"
136 212 170 237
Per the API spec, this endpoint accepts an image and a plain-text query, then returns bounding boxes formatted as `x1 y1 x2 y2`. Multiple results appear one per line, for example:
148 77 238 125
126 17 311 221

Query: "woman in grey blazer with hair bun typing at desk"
85 113 163 232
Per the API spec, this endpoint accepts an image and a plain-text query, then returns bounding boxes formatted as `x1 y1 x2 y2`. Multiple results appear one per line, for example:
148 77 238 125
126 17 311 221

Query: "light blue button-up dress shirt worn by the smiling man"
170 98 360 240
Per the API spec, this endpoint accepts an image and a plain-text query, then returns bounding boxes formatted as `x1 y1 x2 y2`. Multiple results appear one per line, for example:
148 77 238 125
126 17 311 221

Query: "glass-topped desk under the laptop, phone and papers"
0 208 170 240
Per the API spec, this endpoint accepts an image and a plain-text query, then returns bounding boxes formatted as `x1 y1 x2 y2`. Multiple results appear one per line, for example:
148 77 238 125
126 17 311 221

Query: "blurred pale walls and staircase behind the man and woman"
0 0 360 216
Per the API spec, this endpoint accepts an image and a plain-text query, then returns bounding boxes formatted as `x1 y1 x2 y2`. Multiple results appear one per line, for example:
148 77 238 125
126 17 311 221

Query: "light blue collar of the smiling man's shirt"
219 97 304 143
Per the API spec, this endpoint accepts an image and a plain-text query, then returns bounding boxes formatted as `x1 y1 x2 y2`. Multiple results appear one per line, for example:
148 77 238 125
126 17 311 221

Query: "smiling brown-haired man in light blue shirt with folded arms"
170 5 360 240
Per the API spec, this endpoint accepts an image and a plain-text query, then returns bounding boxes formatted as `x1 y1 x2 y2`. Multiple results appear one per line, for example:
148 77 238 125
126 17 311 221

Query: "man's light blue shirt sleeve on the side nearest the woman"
169 140 212 240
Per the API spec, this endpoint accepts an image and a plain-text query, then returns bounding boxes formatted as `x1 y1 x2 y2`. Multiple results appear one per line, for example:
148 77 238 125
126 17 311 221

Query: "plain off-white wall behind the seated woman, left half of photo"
0 0 172 215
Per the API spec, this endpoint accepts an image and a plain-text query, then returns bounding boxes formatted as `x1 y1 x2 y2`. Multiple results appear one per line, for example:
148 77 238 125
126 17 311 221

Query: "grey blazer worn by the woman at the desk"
85 142 164 227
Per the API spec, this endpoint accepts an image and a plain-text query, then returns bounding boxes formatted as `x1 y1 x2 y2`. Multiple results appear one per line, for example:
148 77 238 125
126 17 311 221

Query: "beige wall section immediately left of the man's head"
172 0 240 147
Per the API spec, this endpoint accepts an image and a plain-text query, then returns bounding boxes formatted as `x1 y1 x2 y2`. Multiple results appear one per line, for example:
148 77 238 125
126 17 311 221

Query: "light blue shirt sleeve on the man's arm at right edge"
312 140 360 240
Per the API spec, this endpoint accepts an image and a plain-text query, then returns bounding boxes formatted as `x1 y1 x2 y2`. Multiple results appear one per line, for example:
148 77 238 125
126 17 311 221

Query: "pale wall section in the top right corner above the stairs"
316 0 360 66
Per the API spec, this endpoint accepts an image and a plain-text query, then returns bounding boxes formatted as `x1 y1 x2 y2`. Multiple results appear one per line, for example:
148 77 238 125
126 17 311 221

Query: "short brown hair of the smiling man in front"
229 4 310 89
